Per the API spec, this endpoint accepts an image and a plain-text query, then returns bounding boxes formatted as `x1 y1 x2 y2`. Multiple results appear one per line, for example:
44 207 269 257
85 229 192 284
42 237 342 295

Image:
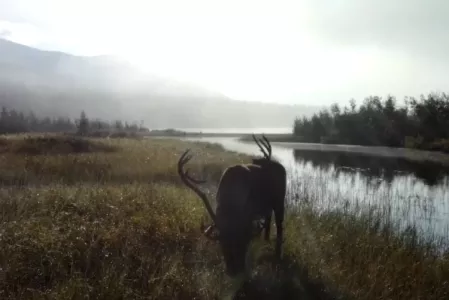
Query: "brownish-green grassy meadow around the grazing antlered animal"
0 137 449 299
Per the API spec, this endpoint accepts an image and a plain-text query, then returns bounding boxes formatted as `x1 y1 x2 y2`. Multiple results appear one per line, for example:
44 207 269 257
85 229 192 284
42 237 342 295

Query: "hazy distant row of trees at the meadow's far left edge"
0 107 148 135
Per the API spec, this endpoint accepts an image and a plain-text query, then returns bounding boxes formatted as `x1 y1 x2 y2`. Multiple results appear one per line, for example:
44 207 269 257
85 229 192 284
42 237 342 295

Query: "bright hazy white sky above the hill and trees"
0 0 449 104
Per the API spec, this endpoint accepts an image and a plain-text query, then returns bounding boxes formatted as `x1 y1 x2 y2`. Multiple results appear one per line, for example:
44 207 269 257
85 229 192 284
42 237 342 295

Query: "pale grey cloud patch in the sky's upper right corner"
300 0 449 62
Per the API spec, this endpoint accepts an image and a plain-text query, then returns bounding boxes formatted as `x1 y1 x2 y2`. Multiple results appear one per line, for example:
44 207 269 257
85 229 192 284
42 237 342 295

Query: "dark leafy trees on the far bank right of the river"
293 93 449 152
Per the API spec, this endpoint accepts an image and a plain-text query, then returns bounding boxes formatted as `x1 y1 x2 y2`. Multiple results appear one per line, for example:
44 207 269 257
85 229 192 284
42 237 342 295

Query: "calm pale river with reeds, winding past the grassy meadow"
177 137 449 245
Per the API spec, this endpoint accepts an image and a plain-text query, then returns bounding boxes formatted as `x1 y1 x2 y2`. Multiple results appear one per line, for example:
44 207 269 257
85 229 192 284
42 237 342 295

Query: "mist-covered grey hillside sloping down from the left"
0 39 319 128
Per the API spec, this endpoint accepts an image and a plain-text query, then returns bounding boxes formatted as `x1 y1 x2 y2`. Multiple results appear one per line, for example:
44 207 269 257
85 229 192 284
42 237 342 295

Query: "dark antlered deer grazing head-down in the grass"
178 134 286 277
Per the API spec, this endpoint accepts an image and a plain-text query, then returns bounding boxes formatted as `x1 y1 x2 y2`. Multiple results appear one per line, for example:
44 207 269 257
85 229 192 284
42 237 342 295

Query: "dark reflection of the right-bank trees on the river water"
293 149 449 186
